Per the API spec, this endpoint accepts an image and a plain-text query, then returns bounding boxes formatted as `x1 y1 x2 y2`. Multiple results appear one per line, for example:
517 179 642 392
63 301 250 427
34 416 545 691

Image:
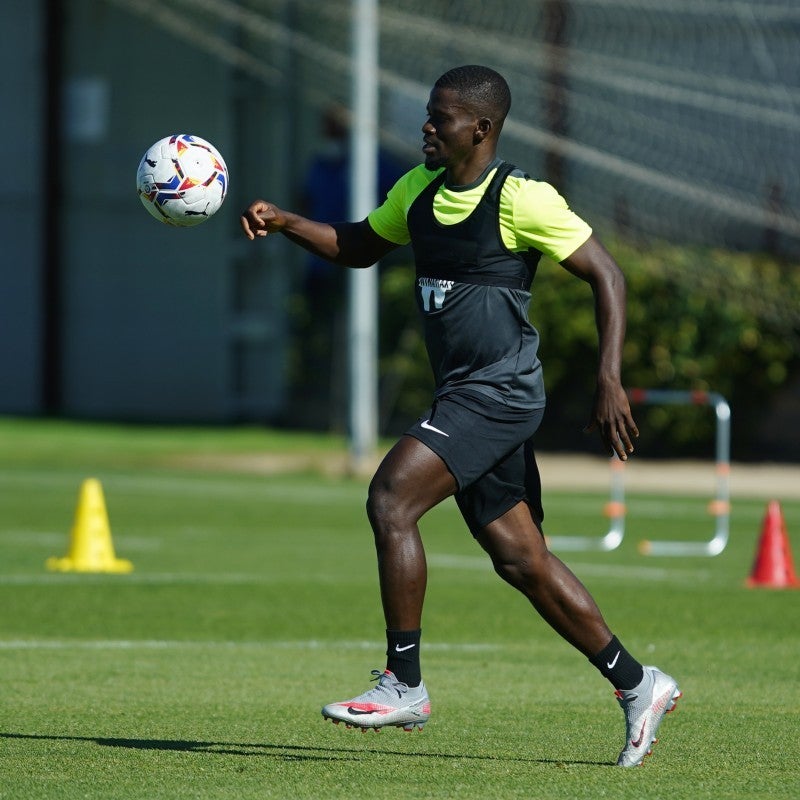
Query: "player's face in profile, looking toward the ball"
422 89 478 170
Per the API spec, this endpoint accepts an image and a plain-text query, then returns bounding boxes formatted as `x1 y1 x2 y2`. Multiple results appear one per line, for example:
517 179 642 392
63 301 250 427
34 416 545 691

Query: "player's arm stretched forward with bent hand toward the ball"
241 200 397 267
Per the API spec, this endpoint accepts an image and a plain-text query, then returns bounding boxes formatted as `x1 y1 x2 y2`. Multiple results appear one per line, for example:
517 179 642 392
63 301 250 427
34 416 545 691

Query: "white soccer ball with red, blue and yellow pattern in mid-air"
136 133 228 227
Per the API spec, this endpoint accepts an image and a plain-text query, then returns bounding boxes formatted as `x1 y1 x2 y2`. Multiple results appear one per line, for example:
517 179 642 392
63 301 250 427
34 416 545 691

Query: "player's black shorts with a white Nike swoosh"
406 396 544 535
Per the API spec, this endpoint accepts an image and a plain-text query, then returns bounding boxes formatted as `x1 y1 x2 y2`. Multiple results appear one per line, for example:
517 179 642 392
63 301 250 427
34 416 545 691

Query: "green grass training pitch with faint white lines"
0 419 800 800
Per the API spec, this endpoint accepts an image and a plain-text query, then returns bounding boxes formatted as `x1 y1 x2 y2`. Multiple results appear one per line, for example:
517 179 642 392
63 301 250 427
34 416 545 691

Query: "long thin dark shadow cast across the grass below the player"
0 732 612 767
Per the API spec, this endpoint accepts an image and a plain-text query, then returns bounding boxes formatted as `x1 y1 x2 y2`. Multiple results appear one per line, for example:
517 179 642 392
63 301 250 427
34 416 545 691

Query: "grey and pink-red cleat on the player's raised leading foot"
322 669 431 731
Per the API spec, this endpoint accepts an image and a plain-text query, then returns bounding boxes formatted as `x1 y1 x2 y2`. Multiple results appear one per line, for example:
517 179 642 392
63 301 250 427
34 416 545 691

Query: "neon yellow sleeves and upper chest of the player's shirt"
367 164 592 261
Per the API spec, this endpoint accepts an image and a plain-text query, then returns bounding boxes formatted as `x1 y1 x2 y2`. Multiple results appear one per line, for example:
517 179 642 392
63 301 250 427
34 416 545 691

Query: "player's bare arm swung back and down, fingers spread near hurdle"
561 236 639 461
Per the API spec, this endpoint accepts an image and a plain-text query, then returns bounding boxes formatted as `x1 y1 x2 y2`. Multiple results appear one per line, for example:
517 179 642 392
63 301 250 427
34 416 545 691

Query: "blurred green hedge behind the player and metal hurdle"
381 241 800 458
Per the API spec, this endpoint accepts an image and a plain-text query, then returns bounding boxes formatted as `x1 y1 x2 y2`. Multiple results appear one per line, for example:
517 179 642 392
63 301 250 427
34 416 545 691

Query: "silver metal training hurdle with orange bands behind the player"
547 389 731 556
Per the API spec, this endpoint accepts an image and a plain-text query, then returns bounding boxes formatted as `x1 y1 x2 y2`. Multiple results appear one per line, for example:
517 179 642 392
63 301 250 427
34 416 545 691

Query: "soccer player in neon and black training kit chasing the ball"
241 65 681 766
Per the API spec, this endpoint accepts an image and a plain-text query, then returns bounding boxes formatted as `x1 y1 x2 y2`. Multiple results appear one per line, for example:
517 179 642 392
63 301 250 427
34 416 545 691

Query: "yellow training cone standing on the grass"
46 478 133 572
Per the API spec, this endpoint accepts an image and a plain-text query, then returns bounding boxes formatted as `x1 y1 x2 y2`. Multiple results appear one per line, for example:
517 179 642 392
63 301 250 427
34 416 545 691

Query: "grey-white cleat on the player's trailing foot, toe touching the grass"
616 667 681 767
